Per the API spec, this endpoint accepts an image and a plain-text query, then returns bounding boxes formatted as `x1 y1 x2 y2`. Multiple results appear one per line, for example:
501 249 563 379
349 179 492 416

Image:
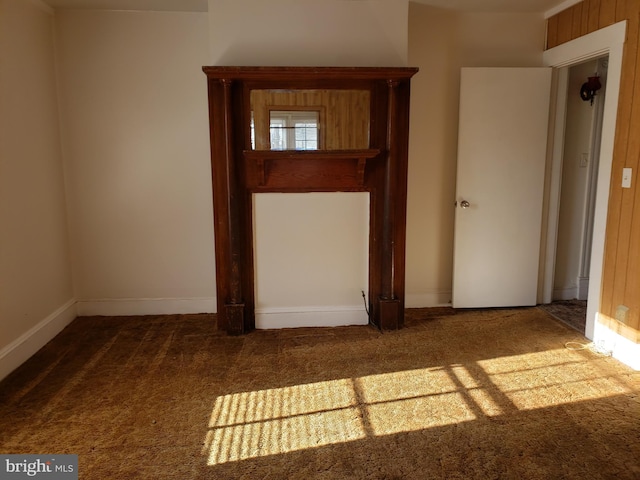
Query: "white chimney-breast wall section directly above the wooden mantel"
209 0 408 67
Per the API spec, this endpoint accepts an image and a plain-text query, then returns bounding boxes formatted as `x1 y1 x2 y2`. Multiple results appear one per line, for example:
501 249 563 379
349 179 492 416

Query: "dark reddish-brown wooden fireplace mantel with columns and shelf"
203 67 418 335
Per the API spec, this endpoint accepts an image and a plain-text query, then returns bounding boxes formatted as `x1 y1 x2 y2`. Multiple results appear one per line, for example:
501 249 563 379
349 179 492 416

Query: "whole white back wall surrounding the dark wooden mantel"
27 0 544 332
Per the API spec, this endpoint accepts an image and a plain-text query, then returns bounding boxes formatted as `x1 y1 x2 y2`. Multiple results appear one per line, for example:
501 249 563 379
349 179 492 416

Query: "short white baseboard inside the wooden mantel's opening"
256 305 369 330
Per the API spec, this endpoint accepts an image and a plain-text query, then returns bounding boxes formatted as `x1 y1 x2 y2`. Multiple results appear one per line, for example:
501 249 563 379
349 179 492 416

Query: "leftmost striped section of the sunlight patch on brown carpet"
205 380 366 465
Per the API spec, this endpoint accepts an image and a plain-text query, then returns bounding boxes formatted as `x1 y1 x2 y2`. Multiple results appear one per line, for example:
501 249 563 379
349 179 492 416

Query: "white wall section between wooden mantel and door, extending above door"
406 3 544 307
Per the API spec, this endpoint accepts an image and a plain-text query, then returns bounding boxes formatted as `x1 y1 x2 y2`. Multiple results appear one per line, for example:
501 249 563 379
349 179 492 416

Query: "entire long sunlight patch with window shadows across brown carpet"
203 349 632 465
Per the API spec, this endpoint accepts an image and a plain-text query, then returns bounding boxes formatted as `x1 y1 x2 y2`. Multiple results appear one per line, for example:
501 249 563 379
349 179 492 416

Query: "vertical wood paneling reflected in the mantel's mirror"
251 90 371 150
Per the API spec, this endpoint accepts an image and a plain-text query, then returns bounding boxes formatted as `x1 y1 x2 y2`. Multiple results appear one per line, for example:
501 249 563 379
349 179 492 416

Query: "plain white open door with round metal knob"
453 68 551 308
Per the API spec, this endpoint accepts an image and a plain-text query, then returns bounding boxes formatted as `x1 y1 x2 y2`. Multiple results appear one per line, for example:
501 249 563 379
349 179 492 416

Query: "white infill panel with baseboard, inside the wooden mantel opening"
253 192 369 329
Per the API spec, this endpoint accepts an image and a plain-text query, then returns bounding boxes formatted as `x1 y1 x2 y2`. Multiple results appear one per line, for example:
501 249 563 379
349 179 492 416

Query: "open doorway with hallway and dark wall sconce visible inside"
545 55 609 334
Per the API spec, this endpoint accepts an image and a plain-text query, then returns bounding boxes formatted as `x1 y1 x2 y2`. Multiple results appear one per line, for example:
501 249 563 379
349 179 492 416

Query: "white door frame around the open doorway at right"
539 20 627 340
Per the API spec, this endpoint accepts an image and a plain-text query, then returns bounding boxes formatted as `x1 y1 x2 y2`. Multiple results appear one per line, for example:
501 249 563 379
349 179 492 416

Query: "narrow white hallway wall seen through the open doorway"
553 60 598 300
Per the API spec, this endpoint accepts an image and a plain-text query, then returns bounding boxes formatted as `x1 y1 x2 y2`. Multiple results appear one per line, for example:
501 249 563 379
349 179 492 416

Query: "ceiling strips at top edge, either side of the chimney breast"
43 0 571 13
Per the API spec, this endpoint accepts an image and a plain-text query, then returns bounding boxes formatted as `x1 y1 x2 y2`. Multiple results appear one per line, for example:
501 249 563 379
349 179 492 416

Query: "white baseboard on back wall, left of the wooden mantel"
78 297 217 317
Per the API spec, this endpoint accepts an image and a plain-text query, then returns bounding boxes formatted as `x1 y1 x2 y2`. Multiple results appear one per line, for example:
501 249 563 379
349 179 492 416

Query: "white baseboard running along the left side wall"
0 298 77 380
